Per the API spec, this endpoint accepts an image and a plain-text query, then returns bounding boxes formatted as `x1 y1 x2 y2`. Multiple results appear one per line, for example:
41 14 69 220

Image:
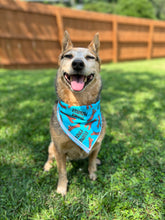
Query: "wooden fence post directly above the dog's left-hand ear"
55 8 64 47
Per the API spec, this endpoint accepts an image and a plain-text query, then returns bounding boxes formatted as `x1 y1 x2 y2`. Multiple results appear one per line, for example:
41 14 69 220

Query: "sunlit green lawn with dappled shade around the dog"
0 59 165 220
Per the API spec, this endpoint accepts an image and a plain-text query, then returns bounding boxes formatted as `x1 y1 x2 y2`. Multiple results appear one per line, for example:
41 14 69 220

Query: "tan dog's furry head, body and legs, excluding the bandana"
44 32 106 196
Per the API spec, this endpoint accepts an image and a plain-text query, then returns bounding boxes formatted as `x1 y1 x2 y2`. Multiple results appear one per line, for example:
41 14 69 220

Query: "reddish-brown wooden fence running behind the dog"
0 0 165 69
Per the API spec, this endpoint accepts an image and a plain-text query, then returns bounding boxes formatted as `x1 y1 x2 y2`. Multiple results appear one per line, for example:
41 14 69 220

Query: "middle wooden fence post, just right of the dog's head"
112 17 118 63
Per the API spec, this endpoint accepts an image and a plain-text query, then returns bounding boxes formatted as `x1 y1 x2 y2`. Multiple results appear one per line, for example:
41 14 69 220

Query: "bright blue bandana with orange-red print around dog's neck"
57 101 102 153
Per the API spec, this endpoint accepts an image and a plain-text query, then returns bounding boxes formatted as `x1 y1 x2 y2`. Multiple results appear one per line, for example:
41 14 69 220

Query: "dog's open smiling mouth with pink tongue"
64 72 94 92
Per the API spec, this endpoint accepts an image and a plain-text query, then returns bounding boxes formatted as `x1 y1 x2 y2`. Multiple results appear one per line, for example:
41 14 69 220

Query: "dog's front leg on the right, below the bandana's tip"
88 144 101 180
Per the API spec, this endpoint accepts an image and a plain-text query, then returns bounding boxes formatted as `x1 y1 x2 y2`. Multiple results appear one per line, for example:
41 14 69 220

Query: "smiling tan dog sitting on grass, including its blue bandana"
44 31 106 196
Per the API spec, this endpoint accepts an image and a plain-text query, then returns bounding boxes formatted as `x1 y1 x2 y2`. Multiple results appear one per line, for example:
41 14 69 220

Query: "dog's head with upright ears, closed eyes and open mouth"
59 31 100 92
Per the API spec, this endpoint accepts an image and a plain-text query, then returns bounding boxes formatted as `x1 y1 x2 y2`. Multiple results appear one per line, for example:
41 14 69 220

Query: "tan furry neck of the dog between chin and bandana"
56 73 101 106
